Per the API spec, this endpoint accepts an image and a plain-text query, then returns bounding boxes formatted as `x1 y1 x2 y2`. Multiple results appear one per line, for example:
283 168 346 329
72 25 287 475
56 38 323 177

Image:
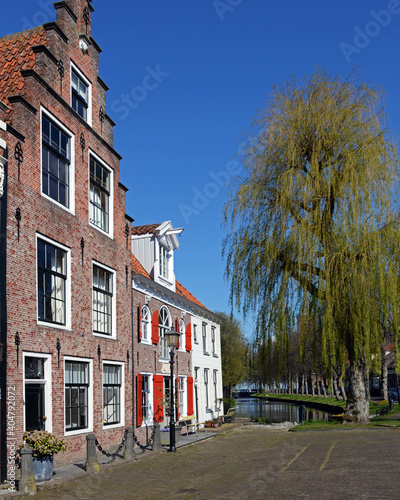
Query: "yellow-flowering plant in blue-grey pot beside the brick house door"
21 431 67 481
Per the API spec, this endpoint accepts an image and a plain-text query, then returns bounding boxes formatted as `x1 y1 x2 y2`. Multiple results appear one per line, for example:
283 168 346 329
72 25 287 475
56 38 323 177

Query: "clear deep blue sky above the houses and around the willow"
1 0 400 335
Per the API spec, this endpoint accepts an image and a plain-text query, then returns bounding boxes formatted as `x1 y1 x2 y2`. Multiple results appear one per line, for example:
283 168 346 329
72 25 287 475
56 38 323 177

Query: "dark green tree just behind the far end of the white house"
216 312 247 397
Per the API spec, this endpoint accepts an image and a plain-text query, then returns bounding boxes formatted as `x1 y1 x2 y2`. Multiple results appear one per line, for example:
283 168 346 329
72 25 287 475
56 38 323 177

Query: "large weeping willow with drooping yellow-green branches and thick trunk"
225 70 400 422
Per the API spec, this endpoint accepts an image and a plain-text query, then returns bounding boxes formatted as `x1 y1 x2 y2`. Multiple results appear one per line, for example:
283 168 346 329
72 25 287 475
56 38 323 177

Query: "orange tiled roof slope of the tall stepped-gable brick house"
0 26 46 108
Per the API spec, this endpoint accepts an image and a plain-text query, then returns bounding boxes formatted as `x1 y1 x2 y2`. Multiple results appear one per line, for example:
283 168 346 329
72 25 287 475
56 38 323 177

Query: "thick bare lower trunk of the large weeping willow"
346 361 369 424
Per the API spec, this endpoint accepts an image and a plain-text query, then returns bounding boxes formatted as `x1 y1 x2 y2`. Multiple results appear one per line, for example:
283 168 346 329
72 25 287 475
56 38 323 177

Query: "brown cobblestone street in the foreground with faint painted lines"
9 426 400 500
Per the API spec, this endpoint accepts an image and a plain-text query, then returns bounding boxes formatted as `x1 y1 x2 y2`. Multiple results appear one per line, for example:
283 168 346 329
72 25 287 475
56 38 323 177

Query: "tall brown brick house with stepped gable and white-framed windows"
0 0 132 475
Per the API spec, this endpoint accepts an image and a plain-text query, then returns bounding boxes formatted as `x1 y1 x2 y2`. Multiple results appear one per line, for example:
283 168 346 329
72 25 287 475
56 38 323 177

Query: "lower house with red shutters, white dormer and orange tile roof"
131 221 223 437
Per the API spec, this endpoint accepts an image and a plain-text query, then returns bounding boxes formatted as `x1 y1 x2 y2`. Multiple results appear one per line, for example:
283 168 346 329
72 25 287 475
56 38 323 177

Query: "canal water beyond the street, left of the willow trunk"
235 398 329 422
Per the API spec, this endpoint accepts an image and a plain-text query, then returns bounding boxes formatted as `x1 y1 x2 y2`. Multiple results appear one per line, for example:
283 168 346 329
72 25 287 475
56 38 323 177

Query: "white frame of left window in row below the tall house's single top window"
40 107 75 214
